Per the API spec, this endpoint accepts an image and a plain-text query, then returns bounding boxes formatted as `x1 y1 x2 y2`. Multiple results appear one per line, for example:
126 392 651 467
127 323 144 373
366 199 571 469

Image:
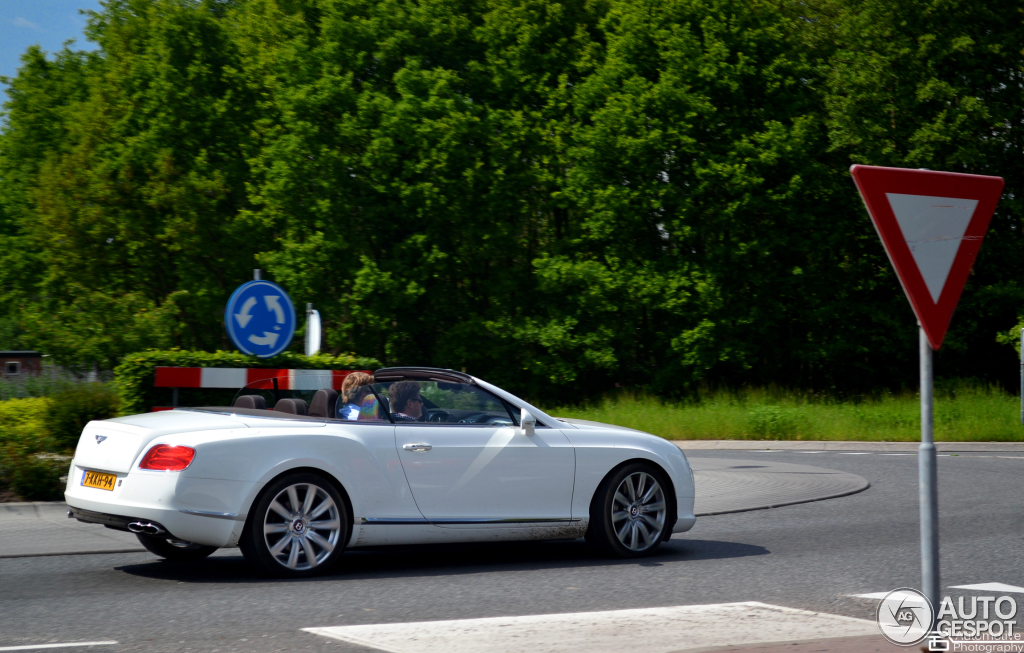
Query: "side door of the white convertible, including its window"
390 382 575 526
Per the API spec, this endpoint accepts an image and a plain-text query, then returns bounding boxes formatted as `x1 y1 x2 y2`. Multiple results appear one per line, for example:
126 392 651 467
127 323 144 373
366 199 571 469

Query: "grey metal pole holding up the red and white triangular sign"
918 328 939 630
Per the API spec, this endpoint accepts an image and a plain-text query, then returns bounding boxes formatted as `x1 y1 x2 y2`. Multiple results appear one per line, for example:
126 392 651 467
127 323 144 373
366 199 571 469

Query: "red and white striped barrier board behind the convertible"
153 367 372 390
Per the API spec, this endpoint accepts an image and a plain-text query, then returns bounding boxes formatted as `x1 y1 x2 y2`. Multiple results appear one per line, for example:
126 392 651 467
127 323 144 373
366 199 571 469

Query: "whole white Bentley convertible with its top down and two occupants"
65 367 695 576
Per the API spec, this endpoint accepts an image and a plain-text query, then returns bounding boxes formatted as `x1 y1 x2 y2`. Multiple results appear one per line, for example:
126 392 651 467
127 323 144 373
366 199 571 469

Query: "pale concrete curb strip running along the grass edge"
669 440 1024 453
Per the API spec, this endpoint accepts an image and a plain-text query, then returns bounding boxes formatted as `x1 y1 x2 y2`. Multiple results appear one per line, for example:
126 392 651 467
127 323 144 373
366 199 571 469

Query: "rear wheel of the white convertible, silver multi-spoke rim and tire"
239 472 352 578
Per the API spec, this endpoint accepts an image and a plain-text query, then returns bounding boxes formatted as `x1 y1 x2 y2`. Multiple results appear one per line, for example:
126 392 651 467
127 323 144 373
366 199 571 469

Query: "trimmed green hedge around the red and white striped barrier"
114 349 380 415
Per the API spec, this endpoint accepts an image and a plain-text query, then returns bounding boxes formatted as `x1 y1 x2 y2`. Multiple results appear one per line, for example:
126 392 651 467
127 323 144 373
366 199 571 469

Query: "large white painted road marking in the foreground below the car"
303 602 879 653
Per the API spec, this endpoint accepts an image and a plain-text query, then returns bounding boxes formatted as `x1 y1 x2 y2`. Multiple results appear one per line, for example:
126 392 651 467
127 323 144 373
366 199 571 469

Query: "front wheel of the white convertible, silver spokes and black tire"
586 463 676 558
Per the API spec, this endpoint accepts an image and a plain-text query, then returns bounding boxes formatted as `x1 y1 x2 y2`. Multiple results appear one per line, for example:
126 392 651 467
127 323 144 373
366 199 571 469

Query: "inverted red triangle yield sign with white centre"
850 166 1002 349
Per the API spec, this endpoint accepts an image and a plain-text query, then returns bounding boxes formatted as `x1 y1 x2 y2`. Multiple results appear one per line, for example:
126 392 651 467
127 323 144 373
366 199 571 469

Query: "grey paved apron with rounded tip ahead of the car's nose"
690 458 870 517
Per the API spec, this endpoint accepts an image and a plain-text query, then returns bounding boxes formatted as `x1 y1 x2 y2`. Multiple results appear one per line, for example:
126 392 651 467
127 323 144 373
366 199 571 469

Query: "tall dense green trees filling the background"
0 0 1024 401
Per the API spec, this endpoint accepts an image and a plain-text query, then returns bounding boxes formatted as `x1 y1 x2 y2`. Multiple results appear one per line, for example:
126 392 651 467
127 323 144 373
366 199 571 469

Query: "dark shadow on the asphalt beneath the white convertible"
116 539 771 583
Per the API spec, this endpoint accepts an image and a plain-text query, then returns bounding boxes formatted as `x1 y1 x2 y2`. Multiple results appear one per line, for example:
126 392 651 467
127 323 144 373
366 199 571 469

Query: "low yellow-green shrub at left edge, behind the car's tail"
0 397 69 500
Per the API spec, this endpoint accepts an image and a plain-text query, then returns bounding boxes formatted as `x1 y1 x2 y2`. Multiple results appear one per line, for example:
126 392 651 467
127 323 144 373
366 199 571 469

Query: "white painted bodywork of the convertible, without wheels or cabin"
65 379 695 547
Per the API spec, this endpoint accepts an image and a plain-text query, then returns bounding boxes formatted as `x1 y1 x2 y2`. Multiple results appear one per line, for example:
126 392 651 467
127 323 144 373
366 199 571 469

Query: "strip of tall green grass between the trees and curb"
549 384 1024 442
